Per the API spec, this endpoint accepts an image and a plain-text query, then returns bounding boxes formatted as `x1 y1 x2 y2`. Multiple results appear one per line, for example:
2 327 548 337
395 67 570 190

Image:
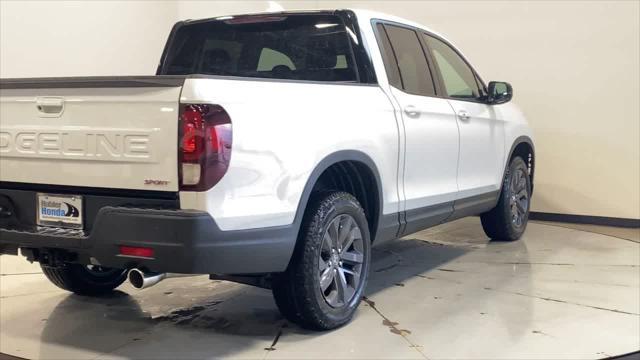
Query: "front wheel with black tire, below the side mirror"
480 156 531 241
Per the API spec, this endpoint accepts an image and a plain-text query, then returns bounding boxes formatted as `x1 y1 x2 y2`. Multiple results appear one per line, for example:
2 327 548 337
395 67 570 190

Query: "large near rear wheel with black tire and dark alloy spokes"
272 192 371 330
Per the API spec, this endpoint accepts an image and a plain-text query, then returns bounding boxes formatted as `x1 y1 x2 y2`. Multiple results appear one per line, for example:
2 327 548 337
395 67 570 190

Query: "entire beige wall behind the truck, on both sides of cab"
0 1 640 219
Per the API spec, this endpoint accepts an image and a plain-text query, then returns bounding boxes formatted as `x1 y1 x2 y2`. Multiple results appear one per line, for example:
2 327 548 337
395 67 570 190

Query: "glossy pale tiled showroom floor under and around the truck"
0 218 640 359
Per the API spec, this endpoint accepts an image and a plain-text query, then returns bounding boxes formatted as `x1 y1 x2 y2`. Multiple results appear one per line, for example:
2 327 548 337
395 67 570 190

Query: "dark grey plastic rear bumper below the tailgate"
0 206 297 274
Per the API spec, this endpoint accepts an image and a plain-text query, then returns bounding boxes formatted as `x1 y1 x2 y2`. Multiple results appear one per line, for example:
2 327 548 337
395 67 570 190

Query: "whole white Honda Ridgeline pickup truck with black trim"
0 10 534 329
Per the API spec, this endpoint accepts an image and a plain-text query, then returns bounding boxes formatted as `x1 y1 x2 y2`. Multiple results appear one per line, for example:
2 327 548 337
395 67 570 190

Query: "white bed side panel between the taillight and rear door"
180 77 399 230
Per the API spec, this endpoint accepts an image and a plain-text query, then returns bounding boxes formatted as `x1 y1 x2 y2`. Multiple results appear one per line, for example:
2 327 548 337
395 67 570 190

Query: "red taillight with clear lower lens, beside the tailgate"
178 104 231 191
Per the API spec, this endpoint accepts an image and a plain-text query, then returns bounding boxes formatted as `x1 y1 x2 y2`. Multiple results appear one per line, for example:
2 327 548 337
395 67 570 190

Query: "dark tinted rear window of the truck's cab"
161 14 358 82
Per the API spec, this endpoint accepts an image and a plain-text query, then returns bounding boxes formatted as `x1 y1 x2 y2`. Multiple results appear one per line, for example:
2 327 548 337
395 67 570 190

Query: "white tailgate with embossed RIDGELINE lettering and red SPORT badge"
0 76 184 191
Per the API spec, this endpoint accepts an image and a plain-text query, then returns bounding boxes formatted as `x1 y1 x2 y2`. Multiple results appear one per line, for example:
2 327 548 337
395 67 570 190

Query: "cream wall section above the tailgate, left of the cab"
0 0 177 78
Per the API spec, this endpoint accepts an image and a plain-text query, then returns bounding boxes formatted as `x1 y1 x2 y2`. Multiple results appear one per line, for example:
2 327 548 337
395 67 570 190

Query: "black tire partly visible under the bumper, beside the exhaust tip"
40 263 127 296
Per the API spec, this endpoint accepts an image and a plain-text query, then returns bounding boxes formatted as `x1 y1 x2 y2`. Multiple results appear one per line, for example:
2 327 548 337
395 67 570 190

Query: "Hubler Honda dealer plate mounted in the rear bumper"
37 194 83 229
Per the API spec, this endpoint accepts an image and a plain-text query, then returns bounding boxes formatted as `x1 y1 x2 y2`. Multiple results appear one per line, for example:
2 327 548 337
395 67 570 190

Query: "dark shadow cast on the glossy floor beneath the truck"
32 233 528 358
